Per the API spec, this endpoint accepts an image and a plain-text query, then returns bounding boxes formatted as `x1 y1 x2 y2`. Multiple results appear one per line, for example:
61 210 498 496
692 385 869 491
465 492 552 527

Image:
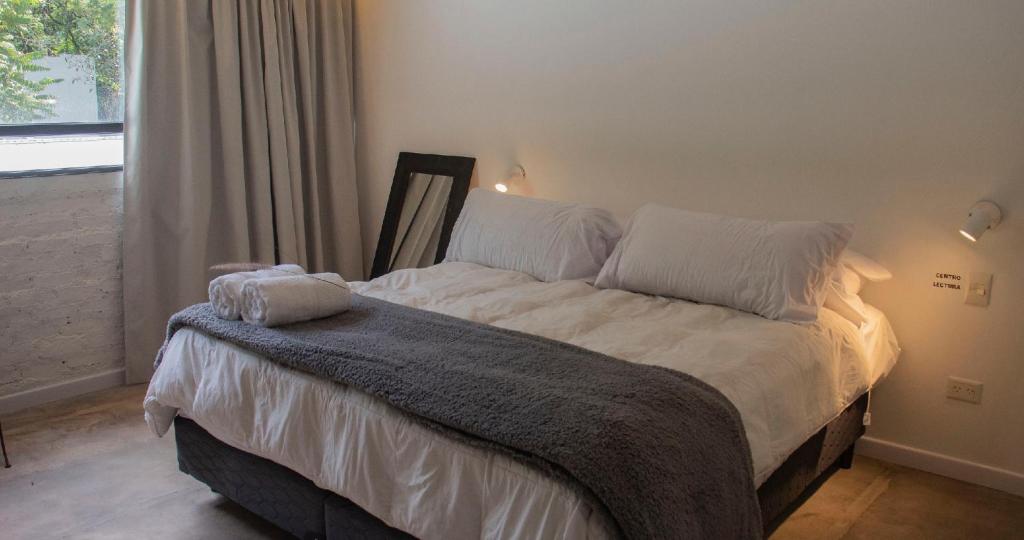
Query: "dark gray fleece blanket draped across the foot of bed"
157 295 762 539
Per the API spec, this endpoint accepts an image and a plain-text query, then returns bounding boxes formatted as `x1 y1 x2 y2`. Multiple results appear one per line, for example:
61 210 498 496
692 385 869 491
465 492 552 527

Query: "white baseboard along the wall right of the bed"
857 437 1024 497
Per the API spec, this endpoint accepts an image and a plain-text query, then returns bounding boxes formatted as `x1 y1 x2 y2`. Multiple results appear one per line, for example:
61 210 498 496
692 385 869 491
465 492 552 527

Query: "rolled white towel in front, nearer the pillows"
242 274 352 327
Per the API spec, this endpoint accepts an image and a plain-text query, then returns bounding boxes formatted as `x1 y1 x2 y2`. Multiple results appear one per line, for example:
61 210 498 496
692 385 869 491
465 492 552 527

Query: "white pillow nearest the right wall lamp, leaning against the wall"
596 204 853 322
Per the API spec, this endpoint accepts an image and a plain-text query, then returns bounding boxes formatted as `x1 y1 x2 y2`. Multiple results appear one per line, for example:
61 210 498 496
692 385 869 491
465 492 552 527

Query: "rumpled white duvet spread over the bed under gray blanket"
145 262 898 538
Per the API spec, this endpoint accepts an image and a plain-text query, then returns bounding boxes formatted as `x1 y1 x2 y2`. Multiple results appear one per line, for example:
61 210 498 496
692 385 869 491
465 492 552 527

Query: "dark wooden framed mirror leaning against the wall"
370 152 476 279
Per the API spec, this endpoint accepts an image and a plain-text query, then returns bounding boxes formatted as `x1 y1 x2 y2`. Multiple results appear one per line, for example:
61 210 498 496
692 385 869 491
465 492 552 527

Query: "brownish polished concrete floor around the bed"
0 385 1024 540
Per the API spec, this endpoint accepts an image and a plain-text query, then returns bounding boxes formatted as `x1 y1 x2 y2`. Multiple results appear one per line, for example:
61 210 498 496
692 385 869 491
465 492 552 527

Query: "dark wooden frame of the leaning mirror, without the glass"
370 152 476 280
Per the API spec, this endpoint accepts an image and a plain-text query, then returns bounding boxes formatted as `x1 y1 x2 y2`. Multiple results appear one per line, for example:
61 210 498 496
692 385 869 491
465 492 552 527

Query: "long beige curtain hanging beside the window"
124 0 362 382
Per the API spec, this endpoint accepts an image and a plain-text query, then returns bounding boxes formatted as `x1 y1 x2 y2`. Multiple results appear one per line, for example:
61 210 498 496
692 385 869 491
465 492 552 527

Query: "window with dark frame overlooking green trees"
0 0 124 176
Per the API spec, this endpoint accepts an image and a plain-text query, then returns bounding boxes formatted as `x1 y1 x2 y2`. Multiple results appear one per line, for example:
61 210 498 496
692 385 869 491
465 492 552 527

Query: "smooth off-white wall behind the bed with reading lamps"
355 0 1024 481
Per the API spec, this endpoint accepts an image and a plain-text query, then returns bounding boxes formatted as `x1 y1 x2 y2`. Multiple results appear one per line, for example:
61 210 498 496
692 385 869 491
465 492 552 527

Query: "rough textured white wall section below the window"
0 172 124 412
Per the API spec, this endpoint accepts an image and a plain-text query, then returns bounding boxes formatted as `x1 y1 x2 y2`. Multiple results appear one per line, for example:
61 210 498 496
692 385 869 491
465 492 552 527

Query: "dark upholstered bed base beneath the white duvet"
174 394 867 540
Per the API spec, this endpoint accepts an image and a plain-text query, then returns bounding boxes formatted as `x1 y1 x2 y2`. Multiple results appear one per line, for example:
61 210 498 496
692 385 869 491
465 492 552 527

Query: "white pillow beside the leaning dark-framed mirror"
444 189 623 282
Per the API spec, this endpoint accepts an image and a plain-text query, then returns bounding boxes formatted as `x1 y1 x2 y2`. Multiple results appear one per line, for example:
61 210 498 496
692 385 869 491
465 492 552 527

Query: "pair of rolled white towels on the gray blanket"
208 264 352 327
